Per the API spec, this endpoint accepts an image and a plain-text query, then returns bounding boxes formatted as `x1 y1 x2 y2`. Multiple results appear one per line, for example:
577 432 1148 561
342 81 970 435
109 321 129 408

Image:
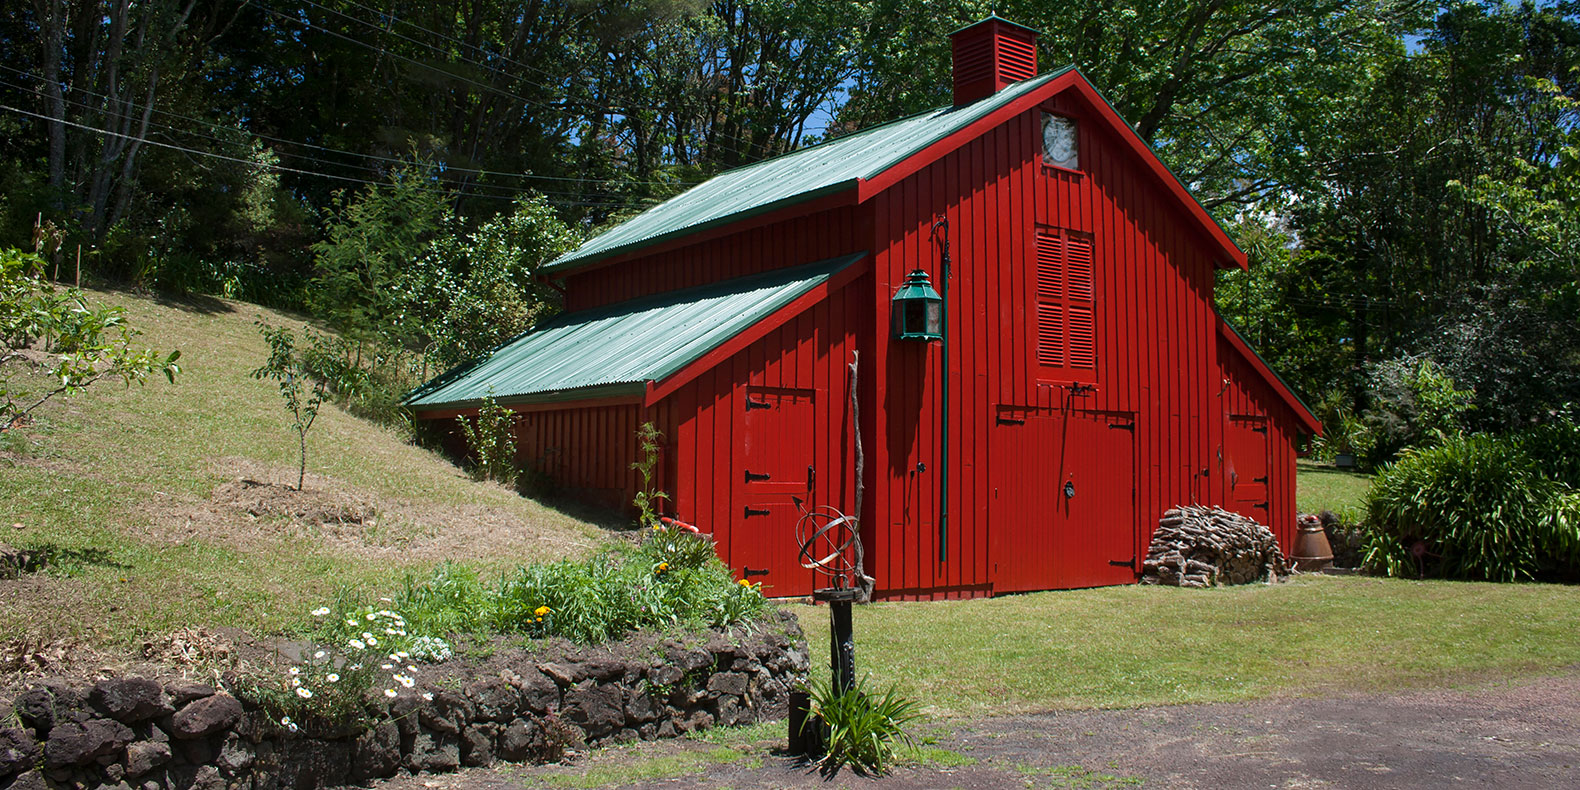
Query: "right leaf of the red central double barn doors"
1051 411 1138 588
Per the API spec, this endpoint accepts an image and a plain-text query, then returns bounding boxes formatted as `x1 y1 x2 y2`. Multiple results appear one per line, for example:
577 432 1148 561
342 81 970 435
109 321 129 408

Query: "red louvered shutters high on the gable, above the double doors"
1035 228 1097 379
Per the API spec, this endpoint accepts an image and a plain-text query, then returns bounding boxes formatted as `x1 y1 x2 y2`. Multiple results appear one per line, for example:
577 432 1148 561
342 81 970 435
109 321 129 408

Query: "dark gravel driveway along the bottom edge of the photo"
366 668 1580 790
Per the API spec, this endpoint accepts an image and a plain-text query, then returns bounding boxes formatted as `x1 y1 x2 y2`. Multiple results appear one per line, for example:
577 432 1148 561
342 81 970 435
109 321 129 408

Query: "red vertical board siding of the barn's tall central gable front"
869 93 1221 599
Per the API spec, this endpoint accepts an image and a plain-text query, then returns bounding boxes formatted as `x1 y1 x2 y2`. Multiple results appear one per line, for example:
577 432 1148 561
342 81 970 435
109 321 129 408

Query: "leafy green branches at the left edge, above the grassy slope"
0 250 182 433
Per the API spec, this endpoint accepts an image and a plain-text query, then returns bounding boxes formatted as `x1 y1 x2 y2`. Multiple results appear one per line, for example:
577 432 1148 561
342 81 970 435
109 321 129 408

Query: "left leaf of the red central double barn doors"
988 408 1060 593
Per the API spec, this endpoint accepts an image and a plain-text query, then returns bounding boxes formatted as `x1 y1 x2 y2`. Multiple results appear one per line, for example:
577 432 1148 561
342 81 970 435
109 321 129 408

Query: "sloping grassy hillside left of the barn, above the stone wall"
0 292 602 654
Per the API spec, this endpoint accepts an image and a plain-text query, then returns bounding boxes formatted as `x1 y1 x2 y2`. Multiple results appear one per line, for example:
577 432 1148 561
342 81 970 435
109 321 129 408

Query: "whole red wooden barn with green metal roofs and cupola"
409 17 1319 599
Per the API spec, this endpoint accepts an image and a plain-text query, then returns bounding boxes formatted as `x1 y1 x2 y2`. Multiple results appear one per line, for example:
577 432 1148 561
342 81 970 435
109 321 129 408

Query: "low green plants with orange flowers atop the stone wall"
395 532 766 643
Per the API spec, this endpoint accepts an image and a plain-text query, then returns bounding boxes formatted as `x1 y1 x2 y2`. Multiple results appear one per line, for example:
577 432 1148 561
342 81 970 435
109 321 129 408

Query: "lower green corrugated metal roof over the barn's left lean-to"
404 253 866 409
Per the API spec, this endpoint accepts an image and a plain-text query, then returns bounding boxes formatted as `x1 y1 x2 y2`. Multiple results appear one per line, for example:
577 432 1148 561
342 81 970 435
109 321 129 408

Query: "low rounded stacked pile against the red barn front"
1141 506 1289 588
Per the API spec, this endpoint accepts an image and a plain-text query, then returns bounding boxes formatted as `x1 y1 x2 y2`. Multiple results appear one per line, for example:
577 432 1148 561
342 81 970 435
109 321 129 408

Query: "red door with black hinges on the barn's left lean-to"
728 387 817 597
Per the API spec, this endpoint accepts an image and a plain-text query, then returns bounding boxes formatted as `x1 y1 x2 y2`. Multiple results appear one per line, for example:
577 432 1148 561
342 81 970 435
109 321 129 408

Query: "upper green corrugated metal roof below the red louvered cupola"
544 66 1073 273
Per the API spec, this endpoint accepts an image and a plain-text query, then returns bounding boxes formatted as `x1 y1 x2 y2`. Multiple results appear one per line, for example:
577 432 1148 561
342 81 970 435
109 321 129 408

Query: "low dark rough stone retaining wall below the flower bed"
0 613 807 790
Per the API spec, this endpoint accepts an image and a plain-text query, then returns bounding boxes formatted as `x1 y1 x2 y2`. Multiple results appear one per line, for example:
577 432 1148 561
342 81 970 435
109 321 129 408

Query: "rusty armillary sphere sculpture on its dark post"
795 498 863 692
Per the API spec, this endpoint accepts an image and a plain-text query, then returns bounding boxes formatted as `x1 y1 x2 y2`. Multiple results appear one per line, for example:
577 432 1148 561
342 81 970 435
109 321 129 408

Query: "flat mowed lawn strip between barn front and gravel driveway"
793 577 1580 716
